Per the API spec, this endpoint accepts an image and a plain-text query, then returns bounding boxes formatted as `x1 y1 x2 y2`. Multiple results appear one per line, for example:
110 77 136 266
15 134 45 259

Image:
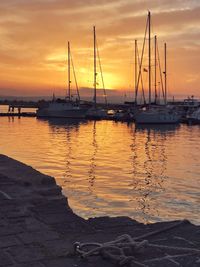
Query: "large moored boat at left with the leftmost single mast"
36 42 88 119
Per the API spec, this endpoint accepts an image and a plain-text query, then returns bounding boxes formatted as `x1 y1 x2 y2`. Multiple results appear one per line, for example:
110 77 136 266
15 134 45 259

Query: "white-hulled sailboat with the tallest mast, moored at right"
134 12 180 124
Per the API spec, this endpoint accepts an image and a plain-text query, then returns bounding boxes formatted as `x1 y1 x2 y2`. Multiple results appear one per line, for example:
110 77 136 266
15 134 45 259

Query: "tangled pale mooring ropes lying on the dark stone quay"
74 220 200 267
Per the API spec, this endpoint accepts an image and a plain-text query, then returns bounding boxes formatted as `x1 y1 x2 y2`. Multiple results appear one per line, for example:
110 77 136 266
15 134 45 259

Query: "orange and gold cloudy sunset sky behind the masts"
0 0 200 101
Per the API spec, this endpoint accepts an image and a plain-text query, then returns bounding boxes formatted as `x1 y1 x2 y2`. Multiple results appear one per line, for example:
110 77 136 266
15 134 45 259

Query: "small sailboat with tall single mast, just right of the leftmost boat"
86 26 108 120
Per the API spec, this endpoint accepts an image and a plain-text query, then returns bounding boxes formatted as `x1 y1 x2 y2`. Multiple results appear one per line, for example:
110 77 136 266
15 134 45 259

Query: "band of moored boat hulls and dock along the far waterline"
0 99 200 124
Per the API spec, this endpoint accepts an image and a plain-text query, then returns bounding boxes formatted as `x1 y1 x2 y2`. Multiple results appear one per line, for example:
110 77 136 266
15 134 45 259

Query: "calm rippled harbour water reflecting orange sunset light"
0 114 200 224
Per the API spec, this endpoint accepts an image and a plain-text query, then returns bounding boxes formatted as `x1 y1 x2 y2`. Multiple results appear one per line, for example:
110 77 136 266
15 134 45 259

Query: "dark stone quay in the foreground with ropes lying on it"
0 155 200 267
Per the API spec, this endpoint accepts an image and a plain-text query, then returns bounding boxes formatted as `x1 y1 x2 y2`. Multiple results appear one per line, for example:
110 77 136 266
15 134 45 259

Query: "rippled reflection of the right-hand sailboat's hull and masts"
130 125 179 222
